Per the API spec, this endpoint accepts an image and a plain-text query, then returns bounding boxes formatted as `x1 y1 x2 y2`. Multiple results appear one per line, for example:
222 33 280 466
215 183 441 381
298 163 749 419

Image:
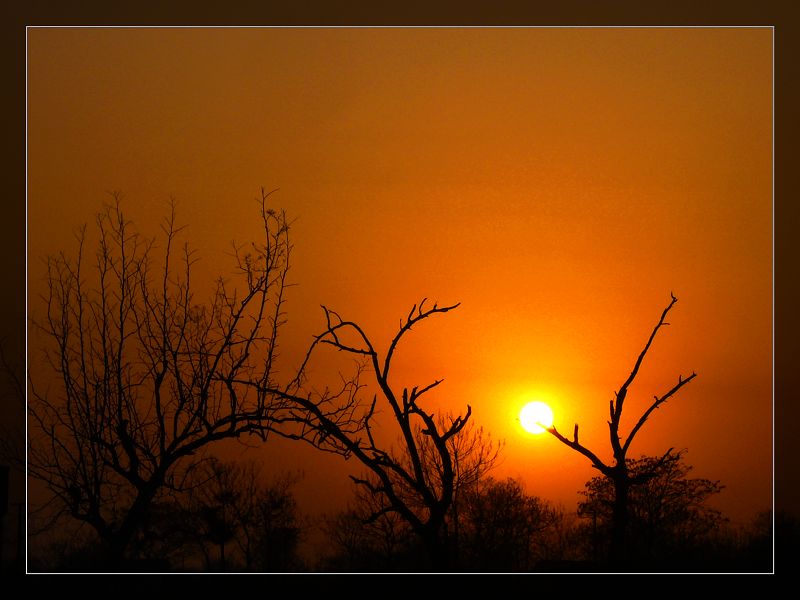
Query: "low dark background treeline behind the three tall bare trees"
29 452 780 573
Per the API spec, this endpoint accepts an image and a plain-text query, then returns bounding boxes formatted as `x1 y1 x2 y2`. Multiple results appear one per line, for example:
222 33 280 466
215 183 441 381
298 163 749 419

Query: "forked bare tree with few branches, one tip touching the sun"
548 294 696 562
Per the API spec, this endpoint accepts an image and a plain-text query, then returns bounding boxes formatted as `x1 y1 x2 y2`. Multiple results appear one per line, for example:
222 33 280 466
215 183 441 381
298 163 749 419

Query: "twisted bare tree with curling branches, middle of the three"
268 300 482 569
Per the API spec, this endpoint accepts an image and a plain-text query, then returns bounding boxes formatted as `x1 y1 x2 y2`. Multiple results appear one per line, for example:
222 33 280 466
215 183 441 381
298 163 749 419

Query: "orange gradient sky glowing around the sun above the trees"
27 28 772 520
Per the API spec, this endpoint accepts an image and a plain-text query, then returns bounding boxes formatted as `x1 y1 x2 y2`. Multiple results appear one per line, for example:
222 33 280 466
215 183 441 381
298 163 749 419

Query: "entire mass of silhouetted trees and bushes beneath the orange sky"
0 195 780 572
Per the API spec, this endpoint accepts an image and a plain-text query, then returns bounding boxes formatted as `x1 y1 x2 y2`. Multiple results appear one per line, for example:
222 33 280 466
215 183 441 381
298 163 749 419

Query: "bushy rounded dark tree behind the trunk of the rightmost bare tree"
578 449 725 566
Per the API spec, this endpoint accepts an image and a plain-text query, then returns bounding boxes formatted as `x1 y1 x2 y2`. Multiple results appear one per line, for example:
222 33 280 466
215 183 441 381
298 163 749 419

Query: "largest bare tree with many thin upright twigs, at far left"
28 189 298 566
